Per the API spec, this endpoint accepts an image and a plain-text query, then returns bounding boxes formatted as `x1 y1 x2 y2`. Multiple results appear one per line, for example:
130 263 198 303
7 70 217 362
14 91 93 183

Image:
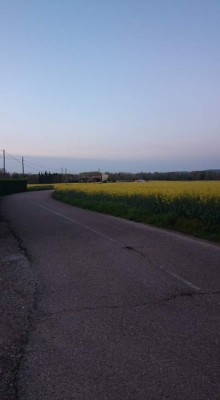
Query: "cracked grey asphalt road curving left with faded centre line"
2 192 220 400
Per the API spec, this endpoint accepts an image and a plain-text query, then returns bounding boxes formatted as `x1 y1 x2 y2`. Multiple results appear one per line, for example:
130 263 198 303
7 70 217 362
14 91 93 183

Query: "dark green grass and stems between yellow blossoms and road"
53 189 220 242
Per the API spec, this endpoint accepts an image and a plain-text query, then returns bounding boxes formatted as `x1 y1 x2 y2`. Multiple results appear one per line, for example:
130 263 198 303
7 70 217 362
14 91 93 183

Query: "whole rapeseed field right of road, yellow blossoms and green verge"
54 181 220 242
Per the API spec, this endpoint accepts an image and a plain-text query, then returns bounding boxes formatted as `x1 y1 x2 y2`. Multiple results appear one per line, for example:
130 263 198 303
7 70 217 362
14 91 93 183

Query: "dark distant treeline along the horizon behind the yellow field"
0 169 220 184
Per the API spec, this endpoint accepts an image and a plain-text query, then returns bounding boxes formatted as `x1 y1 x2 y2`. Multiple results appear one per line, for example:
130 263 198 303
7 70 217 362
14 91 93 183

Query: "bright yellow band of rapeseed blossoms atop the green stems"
55 181 220 198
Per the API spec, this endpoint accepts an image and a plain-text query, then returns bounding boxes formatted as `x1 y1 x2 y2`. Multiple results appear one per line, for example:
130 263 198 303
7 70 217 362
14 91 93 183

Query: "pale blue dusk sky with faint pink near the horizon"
0 0 220 172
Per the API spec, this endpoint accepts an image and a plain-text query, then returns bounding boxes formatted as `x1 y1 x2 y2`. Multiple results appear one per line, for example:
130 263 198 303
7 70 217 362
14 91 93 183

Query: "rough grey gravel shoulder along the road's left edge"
0 212 35 400
